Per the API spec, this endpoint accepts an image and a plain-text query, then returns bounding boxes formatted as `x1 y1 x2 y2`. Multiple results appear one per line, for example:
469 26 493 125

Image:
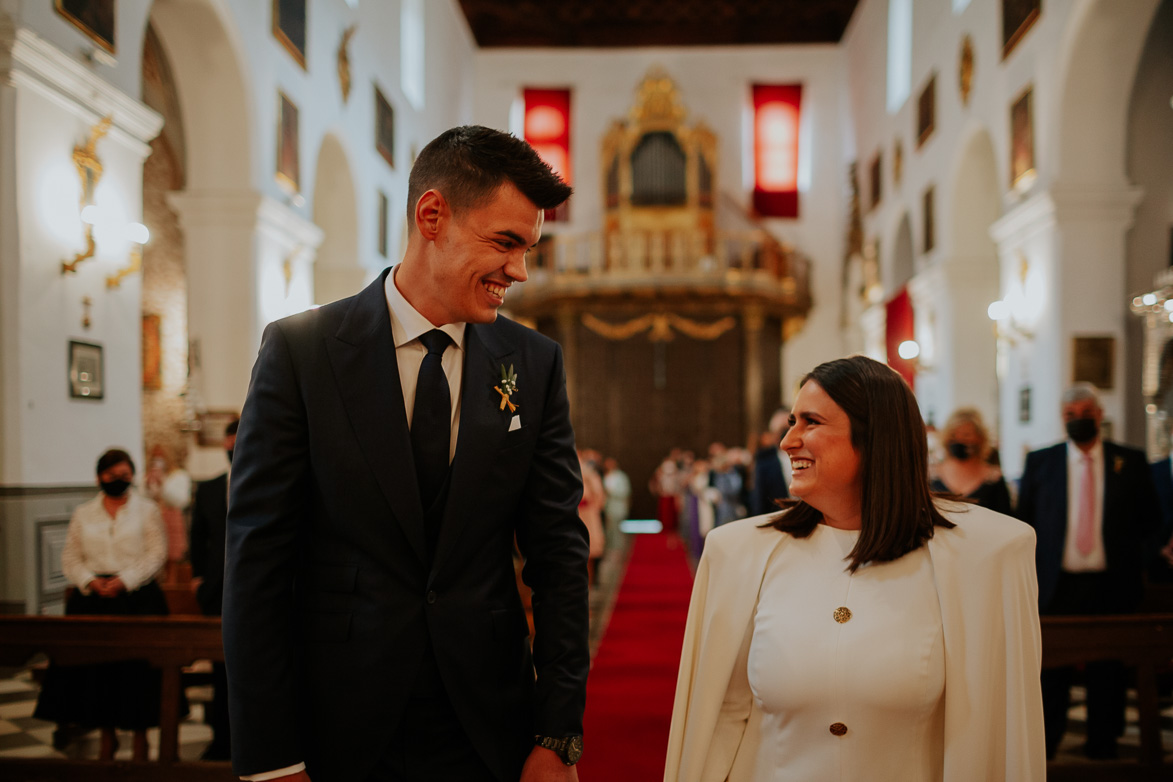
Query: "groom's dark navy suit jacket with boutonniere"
224 271 590 782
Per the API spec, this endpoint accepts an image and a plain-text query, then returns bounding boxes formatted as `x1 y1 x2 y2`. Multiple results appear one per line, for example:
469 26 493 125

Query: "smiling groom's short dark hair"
407 125 574 229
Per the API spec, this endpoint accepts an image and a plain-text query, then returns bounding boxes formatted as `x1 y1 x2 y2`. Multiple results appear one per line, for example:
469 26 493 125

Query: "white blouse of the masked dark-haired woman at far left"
61 489 167 594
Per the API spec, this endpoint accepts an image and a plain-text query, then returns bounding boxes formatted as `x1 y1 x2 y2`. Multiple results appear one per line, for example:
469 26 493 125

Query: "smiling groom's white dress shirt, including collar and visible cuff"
240 265 466 782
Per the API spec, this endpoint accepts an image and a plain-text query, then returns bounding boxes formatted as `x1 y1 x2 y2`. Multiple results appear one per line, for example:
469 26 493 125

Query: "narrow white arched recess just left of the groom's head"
313 134 367 304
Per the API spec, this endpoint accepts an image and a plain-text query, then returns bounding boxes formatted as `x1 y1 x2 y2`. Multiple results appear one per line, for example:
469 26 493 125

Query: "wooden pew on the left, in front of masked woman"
0 616 236 782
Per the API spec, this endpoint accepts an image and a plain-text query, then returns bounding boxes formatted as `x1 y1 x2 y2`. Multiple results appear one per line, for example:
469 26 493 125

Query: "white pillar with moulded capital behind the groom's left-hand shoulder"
170 190 321 410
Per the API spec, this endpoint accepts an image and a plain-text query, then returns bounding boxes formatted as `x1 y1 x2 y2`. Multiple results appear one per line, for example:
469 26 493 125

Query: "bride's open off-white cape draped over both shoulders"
664 505 1046 782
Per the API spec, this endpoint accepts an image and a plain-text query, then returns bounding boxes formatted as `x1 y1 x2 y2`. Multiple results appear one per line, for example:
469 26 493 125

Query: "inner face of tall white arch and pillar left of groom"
150 0 260 409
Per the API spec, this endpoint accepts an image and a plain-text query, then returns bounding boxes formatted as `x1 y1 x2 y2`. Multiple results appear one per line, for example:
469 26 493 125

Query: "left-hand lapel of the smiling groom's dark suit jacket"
326 270 427 562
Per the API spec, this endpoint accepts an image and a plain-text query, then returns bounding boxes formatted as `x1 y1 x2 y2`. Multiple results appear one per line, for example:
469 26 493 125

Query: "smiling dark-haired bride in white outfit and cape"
664 356 1045 782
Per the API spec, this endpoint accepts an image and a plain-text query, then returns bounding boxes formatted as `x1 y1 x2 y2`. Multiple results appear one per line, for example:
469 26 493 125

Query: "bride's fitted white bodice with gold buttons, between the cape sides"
748 524 945 782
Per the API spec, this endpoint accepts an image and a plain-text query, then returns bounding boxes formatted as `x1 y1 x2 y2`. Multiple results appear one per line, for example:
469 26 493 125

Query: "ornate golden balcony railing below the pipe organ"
509 230 811 314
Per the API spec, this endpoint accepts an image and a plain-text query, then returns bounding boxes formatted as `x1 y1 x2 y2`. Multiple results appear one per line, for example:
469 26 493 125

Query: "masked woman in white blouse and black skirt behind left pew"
33 449 168 760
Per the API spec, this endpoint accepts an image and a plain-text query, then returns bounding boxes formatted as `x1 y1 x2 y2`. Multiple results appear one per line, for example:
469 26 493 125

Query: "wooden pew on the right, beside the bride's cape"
1042 613 1173 782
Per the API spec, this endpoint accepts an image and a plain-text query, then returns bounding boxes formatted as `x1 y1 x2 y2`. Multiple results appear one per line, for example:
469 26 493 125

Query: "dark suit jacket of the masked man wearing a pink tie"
1018 441 1157 611
